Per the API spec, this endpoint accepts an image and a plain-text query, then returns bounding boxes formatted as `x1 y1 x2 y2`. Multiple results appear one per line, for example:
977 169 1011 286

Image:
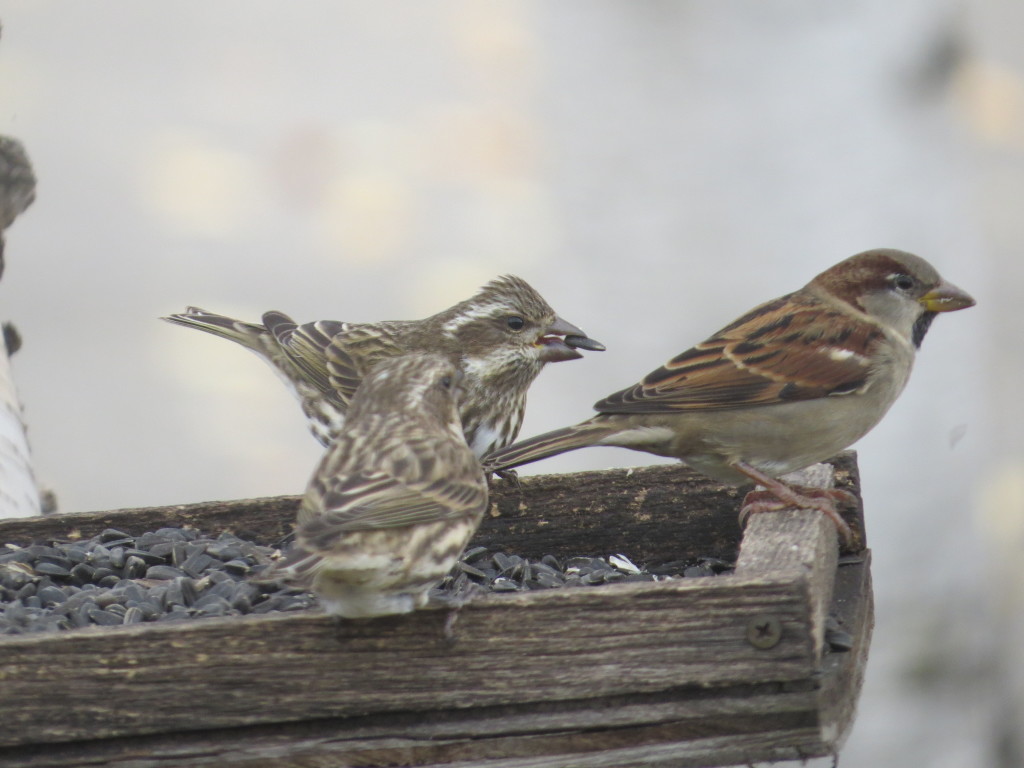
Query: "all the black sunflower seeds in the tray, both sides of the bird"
0 527 732 635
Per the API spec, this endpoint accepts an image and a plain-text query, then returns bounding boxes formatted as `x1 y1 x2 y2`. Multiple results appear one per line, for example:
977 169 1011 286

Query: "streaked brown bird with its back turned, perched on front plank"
259 352 487 618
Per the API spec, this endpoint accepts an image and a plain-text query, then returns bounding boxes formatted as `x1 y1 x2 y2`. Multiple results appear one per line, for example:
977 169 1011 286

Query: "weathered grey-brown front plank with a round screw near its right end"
0 577 816 744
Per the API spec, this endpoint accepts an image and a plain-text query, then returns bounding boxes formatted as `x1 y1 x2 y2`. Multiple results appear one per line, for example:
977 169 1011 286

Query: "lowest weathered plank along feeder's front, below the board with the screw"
0 682 843 768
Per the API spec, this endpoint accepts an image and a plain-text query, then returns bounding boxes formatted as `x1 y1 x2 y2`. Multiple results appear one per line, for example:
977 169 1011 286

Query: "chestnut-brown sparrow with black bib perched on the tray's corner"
483 248 975 543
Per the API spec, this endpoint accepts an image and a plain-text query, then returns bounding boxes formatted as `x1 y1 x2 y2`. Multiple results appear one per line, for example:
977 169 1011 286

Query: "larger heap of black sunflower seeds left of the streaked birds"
0 527 314 634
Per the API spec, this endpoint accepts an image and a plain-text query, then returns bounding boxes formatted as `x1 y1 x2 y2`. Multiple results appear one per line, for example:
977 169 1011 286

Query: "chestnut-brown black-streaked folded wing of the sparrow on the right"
594 293 883 414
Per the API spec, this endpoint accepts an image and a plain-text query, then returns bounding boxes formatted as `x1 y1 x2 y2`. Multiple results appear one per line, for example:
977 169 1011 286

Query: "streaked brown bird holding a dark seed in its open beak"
162 274 604 458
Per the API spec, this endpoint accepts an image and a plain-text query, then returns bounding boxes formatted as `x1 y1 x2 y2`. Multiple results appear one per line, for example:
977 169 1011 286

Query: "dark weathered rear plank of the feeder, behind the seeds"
0 452 861 562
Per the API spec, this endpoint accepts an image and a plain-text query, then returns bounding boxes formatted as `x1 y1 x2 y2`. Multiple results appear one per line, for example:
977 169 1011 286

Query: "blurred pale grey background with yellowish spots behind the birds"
0 0 1024 768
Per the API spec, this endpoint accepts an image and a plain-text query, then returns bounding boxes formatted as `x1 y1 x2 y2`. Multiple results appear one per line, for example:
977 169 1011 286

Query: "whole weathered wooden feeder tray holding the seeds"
0 453 872 768
